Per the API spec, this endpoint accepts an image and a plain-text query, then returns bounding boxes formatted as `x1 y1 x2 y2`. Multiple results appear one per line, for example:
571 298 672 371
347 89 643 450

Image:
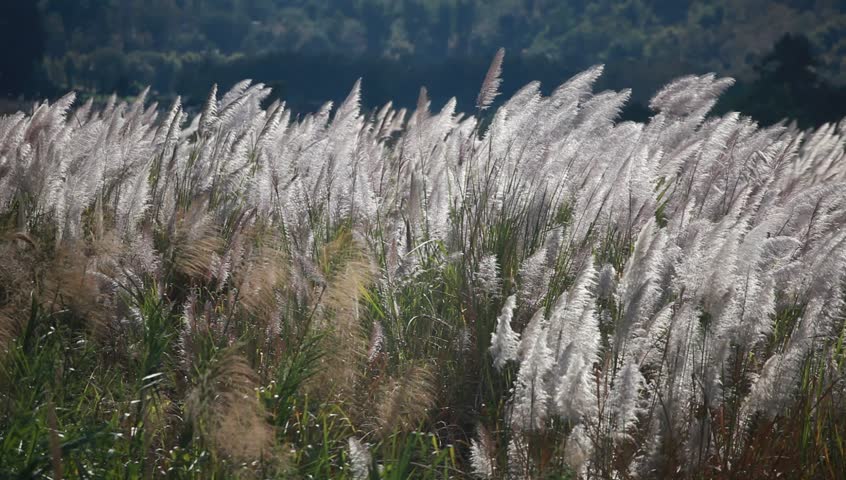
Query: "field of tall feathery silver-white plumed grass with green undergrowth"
0 51 846 479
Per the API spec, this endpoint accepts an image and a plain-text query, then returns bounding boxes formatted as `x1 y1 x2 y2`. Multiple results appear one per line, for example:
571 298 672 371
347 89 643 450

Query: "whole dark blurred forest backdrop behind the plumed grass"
0 0 846 127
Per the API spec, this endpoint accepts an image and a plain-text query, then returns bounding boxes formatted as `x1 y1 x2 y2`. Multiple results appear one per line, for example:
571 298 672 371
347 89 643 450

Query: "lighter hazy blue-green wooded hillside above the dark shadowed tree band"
39 0 846 76
